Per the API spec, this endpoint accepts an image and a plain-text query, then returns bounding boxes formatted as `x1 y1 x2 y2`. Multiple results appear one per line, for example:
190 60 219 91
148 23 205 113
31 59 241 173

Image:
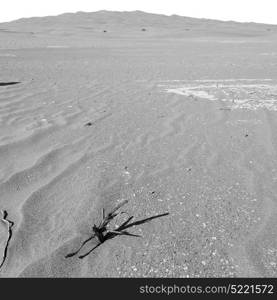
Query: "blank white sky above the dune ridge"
0 0 277 24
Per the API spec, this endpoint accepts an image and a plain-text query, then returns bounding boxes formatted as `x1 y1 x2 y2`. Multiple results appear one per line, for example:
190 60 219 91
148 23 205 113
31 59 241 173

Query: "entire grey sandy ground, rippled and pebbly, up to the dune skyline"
0 12 277 277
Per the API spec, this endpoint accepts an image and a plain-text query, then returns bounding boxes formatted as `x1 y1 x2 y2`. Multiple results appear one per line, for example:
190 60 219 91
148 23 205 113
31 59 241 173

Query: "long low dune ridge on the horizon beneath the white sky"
0 10 277 35
